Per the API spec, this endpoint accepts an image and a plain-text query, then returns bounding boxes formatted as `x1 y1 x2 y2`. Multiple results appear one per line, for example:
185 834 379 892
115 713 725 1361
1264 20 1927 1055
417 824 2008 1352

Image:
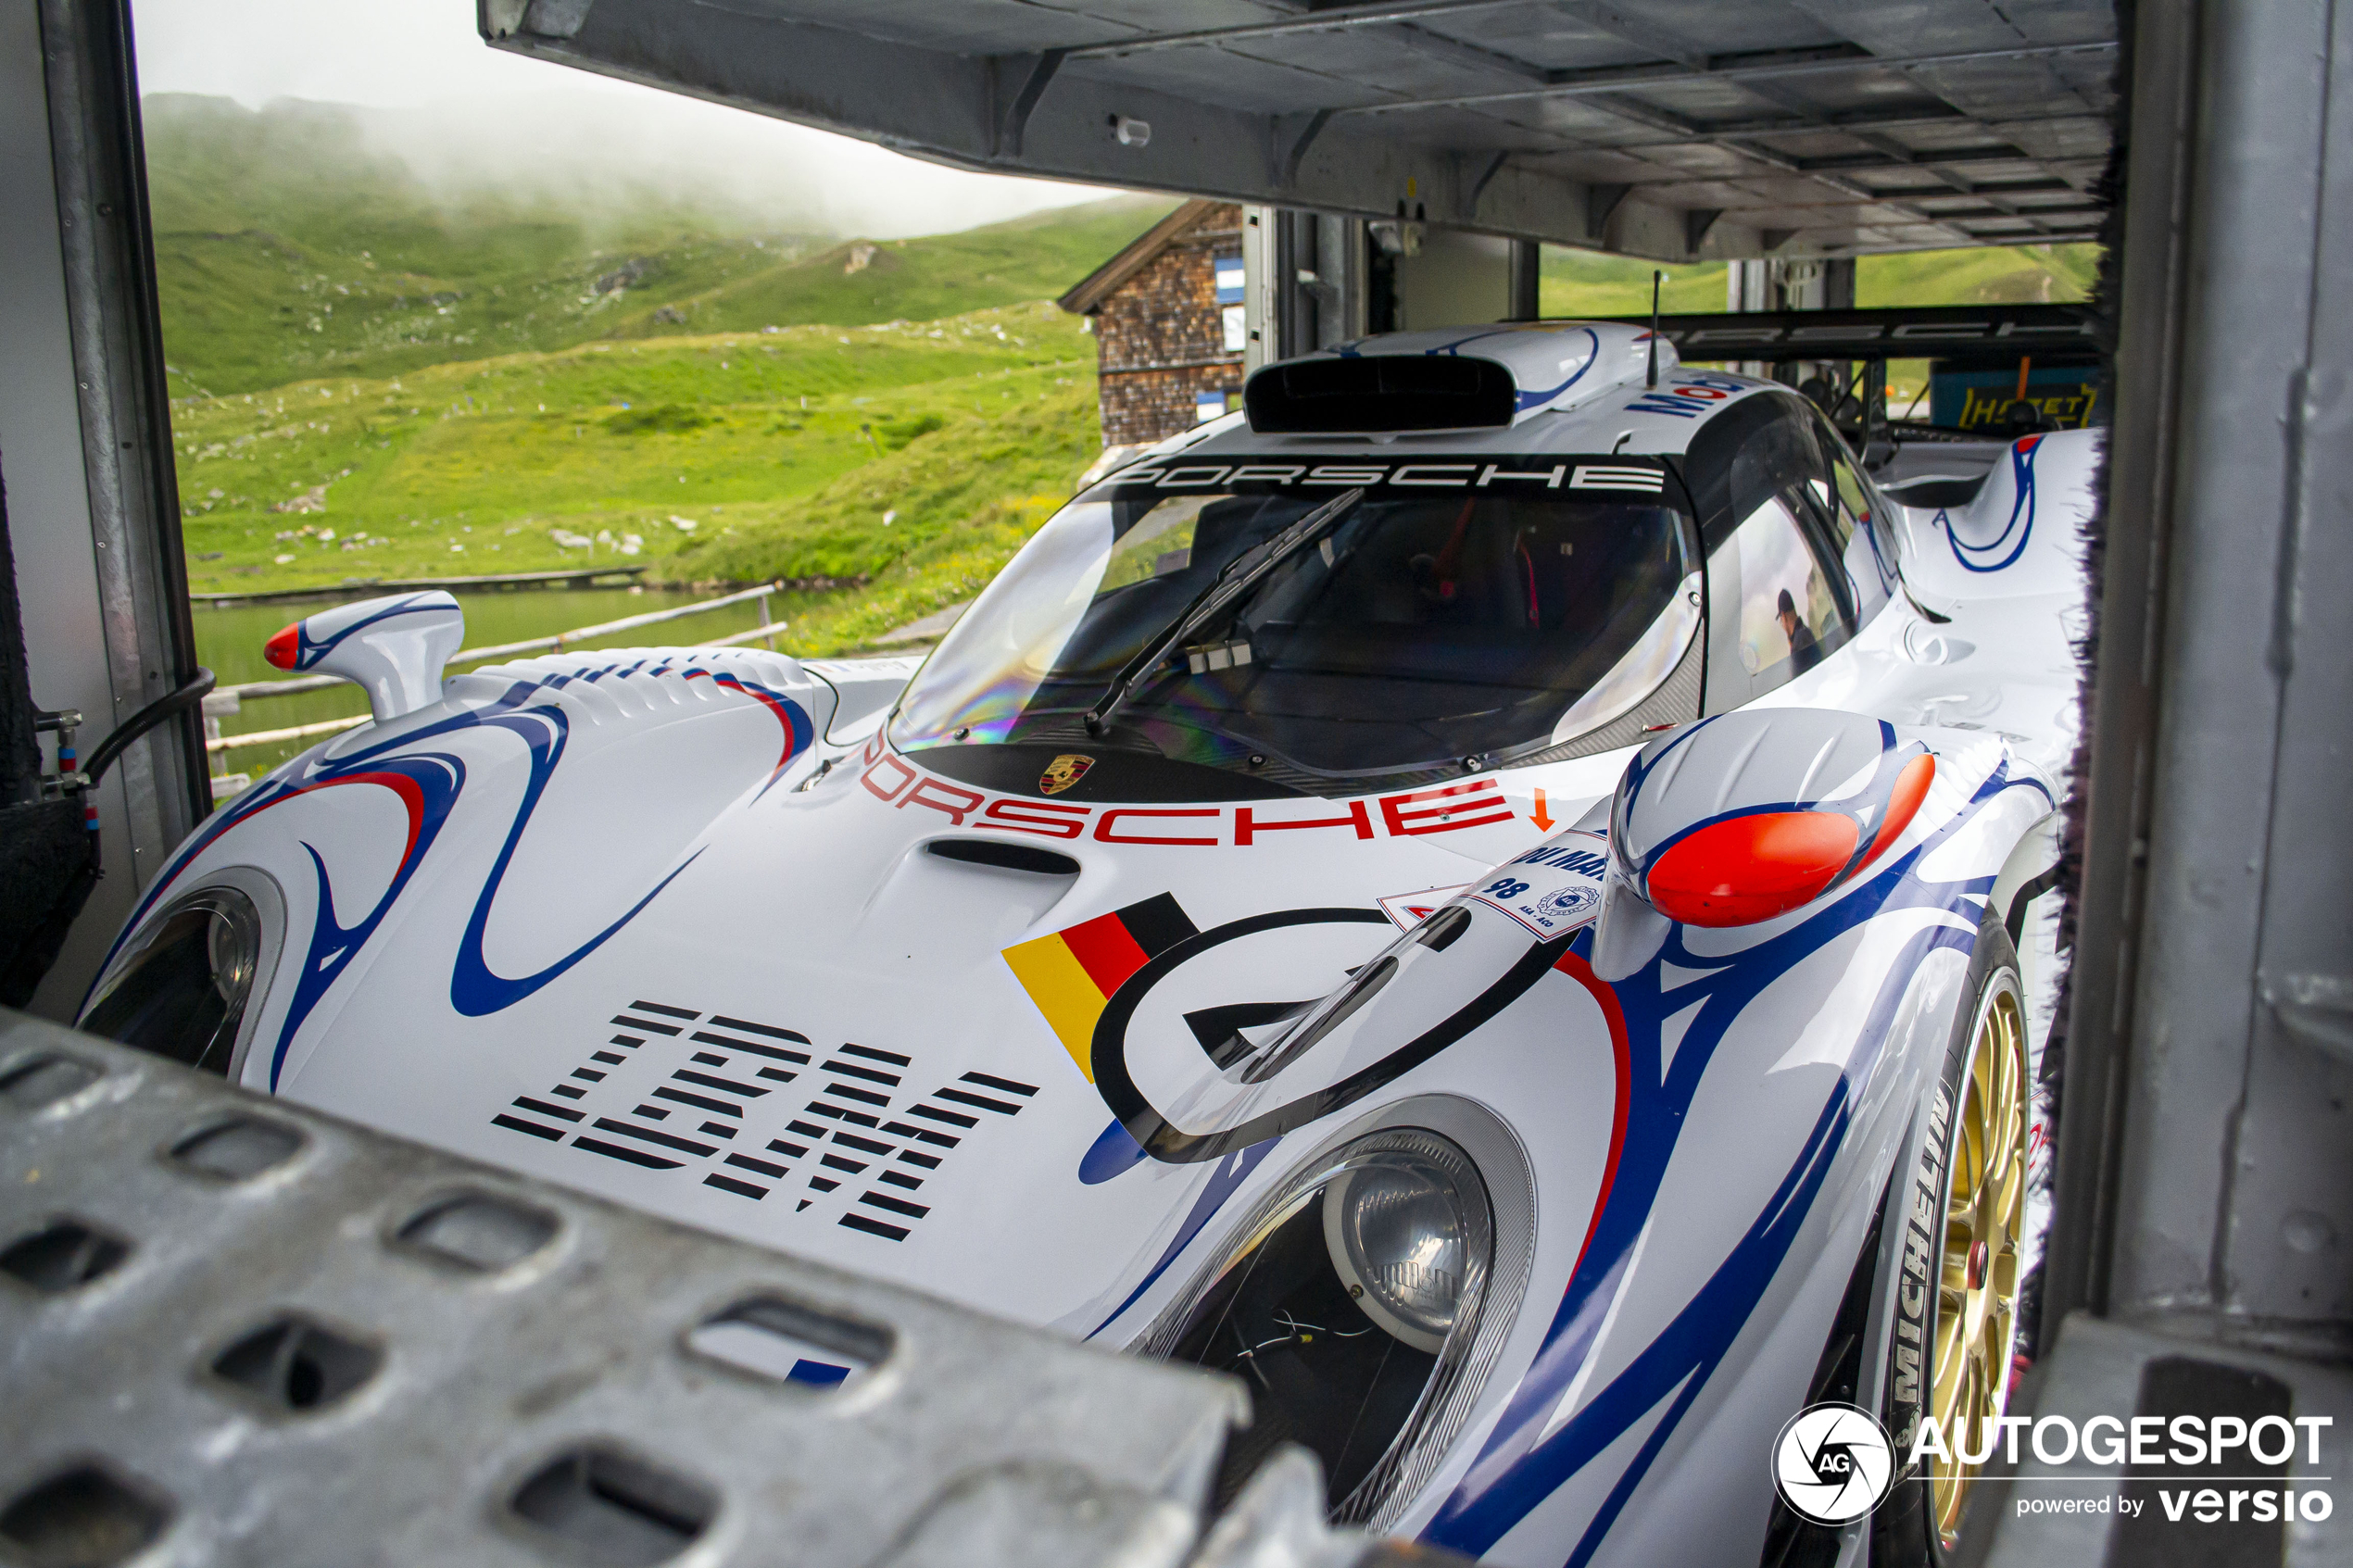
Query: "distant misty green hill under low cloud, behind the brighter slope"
144 94 1169 395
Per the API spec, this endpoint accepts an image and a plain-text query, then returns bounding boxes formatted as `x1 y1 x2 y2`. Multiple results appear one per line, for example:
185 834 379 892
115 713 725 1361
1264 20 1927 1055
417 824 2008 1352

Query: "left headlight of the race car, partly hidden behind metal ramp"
82 886 261 1074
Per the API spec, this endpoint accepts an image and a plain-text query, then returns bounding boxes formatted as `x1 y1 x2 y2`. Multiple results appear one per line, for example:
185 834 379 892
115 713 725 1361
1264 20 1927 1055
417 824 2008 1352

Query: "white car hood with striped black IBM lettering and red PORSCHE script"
247 709 1569 1333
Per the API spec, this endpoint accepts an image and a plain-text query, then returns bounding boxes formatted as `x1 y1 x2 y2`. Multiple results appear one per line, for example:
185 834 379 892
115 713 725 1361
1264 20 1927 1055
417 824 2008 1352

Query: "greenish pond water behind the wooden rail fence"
195 588 814 799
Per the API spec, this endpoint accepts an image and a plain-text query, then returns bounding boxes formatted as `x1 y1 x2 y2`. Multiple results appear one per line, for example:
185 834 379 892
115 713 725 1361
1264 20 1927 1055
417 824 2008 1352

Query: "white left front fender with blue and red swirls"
84 649 833 1091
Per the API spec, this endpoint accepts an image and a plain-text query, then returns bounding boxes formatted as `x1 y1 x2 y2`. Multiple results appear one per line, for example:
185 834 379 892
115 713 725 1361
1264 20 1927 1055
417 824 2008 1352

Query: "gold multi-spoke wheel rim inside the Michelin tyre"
1930 985 2026 1549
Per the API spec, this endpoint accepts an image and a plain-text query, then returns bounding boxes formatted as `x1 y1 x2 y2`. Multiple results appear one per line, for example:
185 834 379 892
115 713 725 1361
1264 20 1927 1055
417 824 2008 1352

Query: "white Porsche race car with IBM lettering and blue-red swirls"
84 324 2099 1568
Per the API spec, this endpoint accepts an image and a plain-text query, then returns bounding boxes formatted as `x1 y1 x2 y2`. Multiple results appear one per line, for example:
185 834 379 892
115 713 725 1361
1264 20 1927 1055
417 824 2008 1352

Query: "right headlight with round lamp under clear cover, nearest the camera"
1139 1126 1496 1524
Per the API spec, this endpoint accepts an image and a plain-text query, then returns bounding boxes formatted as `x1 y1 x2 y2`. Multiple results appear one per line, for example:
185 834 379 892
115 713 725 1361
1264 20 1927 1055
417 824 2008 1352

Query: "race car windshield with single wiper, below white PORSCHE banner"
892 458 1699 778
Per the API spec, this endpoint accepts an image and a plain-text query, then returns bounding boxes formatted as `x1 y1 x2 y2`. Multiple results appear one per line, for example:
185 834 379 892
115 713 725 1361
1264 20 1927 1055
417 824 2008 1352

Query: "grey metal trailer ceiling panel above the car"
478 0 2115 261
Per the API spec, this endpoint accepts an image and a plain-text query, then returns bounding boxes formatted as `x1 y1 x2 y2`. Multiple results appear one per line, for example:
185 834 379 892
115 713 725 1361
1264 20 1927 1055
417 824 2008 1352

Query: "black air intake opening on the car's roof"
1242 355 1517 435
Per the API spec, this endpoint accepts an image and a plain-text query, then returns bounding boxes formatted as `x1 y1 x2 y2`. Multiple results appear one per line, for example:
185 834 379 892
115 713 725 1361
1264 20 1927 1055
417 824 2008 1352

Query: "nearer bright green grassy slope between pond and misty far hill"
171 303 1099 610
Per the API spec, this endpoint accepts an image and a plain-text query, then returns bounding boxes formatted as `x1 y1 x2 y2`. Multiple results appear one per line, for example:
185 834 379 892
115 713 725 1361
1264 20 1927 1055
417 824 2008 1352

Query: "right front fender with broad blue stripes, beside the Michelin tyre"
1184 715 2049 1563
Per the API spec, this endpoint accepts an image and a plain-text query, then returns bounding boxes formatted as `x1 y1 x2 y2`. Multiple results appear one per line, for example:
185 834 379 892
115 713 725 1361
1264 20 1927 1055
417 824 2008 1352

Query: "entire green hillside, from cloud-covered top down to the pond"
145 99 1169 677
